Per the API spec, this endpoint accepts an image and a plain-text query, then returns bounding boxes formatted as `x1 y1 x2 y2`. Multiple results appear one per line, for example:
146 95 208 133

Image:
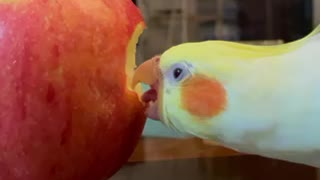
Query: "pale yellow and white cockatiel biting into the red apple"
132 25 320 167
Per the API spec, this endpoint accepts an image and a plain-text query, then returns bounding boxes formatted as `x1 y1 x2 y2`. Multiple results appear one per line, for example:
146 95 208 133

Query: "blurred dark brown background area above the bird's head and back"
135 0 319 62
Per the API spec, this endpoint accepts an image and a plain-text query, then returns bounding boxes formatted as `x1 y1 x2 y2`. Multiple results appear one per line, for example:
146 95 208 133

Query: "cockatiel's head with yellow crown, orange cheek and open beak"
133 42 246 135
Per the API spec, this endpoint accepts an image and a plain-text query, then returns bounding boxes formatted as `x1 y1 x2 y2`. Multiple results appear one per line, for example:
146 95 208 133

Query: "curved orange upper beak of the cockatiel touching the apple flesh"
131 56 160 89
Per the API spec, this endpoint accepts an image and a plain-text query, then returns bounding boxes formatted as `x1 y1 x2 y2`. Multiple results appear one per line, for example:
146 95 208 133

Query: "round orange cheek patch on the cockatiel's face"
181 75 227 118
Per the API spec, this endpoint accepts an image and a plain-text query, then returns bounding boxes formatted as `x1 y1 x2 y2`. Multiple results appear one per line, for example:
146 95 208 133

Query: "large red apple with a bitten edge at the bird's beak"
0 0 146 180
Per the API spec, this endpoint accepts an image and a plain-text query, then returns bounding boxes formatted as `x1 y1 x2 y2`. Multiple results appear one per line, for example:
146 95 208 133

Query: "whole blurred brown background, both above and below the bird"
111 0 320 180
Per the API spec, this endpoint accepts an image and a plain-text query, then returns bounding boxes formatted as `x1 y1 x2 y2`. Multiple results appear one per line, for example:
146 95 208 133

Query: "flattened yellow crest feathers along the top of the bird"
161 25 320 65
